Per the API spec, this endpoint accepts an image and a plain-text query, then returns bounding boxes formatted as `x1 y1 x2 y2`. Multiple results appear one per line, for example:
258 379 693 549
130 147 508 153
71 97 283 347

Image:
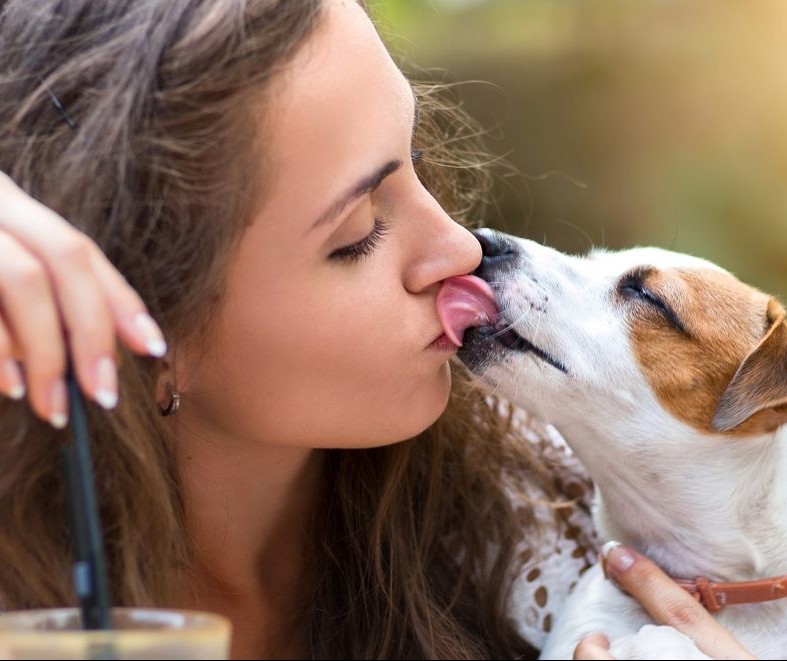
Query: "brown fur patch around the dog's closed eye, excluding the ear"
629 269 772 435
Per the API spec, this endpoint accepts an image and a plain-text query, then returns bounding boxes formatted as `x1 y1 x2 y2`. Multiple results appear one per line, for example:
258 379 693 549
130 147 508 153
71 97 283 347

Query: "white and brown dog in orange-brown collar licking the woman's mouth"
438 230 787 659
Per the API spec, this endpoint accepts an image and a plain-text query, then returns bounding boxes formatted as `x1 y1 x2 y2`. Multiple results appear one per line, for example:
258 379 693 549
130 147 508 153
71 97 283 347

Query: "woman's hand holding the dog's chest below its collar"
574 546 755 659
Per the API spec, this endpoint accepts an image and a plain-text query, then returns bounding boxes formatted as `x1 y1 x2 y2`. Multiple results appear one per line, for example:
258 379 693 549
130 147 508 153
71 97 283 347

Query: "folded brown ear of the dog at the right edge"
712 299 787 432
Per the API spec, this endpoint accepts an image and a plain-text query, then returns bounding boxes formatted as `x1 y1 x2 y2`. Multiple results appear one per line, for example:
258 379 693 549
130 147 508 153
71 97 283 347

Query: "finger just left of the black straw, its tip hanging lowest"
0 232 67 428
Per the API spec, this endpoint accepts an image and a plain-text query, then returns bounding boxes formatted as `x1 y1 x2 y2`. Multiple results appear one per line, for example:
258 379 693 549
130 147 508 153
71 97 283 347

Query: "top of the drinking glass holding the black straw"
0 608 231 659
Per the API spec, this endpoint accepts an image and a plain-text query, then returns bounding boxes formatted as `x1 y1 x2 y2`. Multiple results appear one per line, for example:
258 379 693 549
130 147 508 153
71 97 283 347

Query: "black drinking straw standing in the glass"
60 365 111 629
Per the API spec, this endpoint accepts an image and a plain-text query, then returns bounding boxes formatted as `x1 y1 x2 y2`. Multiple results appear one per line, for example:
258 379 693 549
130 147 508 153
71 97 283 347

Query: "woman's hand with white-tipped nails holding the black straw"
0 172 166 427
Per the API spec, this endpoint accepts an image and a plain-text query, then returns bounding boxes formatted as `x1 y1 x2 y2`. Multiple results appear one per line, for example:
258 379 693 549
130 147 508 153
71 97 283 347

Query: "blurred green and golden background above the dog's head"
369 0 787 301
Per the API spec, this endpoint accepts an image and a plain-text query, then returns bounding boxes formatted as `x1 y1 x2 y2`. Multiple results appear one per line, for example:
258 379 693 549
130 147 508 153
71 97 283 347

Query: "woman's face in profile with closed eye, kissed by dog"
178 0 481 448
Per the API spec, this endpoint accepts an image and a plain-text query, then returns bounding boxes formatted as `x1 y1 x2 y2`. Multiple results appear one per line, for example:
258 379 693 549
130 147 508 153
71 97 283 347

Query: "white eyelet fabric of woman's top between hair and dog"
502 411 598 648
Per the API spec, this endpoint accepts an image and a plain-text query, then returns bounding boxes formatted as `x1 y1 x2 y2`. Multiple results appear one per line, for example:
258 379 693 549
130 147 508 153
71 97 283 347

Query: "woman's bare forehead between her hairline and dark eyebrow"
258 0 414 227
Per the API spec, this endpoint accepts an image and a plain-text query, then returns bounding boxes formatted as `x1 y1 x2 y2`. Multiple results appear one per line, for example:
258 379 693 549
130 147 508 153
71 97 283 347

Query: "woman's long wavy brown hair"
0 0 556 658
